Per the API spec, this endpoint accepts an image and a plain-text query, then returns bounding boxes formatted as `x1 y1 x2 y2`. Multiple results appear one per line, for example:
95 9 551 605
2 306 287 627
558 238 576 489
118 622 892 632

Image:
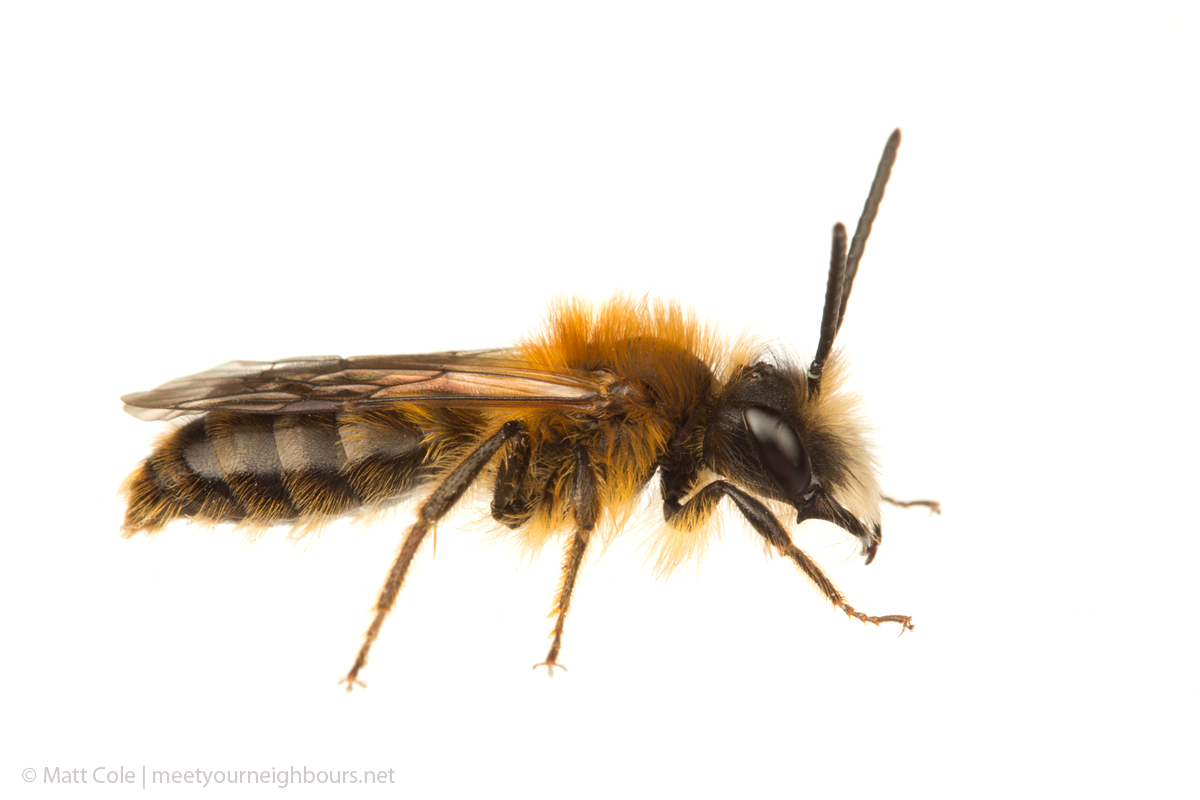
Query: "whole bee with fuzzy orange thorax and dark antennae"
122 131 936 691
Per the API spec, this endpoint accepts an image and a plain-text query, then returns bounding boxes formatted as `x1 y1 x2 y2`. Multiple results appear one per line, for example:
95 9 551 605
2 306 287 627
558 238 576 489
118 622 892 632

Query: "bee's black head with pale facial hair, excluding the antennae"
704 354 881 564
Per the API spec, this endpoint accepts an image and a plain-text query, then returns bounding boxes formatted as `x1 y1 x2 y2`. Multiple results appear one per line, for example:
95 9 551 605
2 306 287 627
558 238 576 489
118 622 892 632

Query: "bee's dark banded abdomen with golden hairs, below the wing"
124 413 427 536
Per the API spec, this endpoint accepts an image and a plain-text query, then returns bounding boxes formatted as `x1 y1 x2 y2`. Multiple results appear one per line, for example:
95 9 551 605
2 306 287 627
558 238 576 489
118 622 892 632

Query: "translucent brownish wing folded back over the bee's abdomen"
121 350 611 420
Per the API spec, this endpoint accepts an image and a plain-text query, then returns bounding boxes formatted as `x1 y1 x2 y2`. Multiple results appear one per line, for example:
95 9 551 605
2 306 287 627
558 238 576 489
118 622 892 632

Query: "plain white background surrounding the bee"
0 2 1200 798
